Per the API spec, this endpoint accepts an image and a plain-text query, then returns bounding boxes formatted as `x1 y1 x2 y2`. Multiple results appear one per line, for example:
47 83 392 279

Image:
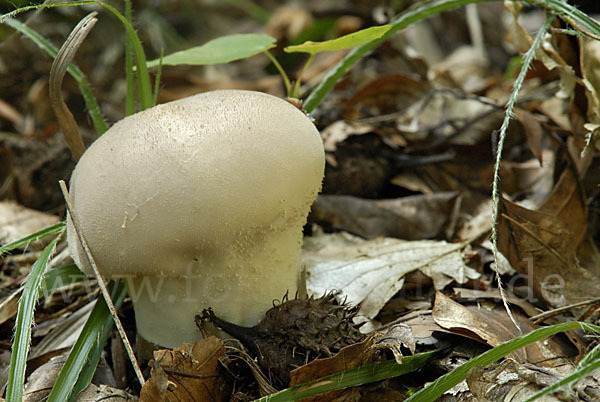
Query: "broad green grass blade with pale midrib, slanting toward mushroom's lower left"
48 281 127 402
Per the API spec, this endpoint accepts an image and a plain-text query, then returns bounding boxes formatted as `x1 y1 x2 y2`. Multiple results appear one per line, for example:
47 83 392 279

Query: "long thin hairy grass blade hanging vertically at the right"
492 15 554 333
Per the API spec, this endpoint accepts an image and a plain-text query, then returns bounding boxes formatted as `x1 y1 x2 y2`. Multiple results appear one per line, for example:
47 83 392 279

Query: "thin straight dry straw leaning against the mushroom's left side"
59 180 145 386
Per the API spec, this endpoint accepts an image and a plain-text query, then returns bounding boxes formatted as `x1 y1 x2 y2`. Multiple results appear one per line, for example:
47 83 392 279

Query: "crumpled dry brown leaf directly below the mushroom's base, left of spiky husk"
140 336 231 402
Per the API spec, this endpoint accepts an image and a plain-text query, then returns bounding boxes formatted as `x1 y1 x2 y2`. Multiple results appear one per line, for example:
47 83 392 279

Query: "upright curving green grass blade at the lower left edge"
6 233 62 402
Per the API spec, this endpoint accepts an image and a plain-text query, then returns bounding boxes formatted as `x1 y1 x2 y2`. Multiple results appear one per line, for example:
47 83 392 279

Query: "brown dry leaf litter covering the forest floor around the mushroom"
0 2 600 400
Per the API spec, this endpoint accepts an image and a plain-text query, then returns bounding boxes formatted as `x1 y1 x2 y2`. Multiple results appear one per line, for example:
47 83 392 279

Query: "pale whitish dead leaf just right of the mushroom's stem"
303 233 479 318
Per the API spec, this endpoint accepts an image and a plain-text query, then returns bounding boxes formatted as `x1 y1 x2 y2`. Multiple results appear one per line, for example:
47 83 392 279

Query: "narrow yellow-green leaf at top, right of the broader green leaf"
283 25 392 54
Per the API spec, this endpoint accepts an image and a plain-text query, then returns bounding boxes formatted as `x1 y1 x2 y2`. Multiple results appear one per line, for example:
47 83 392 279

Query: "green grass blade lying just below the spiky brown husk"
256 350 437 402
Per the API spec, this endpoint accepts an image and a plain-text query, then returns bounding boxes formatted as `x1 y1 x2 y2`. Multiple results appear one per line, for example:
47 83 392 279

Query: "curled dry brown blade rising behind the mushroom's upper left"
48 11 98 161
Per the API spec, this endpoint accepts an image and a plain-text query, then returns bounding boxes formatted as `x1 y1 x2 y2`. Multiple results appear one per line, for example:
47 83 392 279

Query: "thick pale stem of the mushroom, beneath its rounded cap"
124 228 302 348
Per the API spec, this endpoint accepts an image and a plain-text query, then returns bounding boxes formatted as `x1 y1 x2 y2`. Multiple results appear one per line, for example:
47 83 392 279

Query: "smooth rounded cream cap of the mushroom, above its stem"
67 90 325 280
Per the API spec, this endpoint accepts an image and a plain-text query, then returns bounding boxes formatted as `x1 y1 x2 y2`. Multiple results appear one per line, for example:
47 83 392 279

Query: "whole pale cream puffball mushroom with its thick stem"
67 90 325 347
